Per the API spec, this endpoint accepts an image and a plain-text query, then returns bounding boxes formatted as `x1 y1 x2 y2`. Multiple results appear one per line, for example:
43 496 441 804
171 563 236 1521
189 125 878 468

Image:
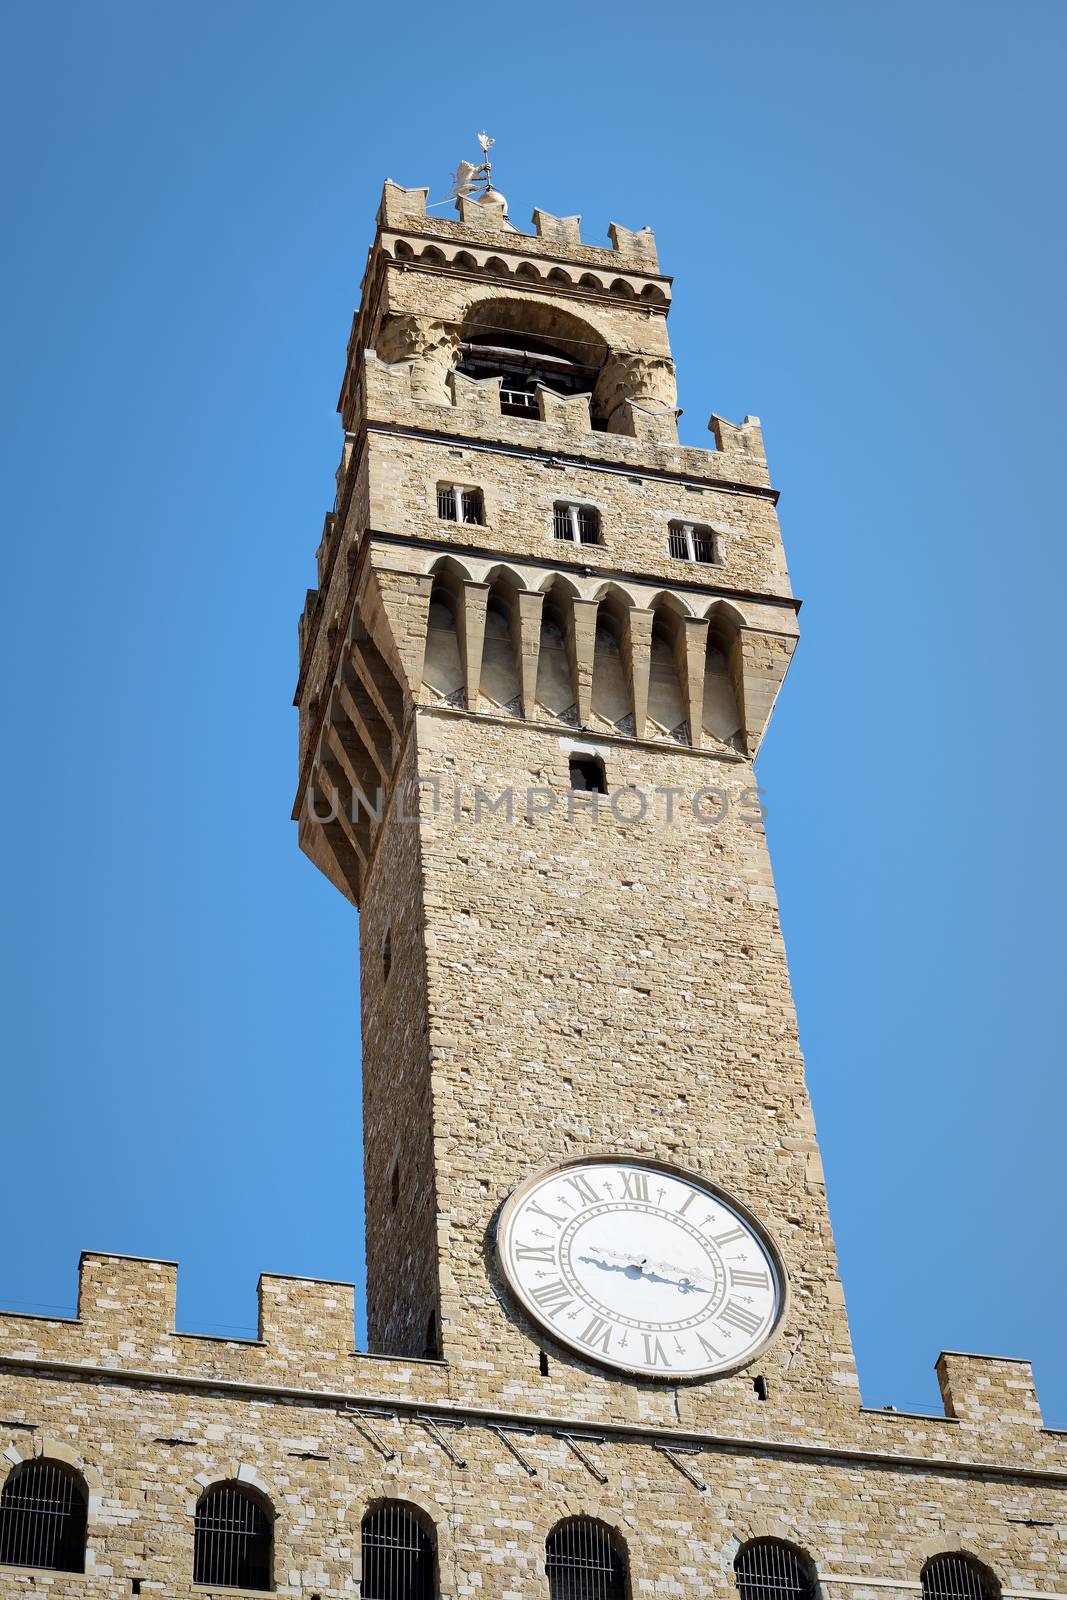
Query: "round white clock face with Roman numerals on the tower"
496 1157 784 1379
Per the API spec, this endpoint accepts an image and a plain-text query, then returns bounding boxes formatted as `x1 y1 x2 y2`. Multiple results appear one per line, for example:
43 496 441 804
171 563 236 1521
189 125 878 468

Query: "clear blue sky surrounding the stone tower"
0 0 1067 1427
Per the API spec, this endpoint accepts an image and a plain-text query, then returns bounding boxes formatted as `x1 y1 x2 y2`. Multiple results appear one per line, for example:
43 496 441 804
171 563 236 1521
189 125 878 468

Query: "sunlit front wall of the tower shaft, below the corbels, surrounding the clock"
418 710 856 1427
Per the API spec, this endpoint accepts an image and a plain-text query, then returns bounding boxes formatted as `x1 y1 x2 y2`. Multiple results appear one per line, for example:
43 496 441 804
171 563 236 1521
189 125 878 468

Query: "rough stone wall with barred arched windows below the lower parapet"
0 1312 1067 1600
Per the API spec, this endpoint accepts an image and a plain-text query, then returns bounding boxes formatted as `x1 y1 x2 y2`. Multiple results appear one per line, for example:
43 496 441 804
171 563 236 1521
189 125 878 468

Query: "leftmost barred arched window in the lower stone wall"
0 1459 88 1573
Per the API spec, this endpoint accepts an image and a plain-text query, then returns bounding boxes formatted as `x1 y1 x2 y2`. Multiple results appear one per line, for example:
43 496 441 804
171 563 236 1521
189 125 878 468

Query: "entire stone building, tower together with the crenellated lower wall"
0 173 1067 1600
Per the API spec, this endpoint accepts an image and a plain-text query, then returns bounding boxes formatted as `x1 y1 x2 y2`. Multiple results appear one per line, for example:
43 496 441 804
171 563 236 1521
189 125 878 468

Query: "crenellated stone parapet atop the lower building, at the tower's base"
0 1251 1067 1472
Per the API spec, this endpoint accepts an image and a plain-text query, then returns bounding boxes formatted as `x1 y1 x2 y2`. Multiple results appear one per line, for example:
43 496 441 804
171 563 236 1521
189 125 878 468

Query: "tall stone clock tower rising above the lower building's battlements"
296 175 856 1416
